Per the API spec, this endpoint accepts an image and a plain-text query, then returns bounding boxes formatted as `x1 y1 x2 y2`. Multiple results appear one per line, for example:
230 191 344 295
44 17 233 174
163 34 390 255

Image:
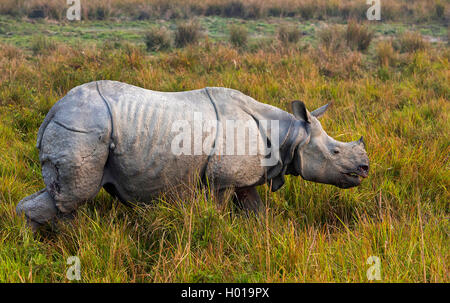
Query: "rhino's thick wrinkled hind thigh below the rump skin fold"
40 123 110 214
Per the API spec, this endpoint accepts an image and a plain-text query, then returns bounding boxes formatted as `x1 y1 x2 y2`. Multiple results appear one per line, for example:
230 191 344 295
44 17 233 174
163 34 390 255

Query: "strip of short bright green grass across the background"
0 15 448 48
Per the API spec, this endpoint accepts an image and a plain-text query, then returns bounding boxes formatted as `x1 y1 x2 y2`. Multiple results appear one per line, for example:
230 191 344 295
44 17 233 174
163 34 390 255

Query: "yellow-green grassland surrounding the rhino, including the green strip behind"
0 6 450 282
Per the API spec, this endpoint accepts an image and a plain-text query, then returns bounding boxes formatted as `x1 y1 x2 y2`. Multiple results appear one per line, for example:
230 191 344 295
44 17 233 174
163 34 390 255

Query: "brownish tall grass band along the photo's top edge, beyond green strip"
0 0 449 21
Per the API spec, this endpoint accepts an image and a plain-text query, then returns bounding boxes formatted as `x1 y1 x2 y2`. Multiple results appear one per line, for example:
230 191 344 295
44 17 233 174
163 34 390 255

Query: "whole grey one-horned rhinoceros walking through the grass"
16 80 369 229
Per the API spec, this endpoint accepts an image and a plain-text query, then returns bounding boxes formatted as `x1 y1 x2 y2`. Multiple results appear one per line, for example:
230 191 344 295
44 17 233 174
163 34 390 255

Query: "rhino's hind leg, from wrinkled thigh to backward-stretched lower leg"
17 122 109 228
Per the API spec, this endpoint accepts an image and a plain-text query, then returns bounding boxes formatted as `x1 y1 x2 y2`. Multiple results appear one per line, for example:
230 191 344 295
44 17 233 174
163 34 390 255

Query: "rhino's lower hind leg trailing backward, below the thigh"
16 188 58 231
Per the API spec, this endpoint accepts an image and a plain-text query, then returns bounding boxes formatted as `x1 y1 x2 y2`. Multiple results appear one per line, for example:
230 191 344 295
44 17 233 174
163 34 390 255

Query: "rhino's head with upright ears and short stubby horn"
291 101 369 188
